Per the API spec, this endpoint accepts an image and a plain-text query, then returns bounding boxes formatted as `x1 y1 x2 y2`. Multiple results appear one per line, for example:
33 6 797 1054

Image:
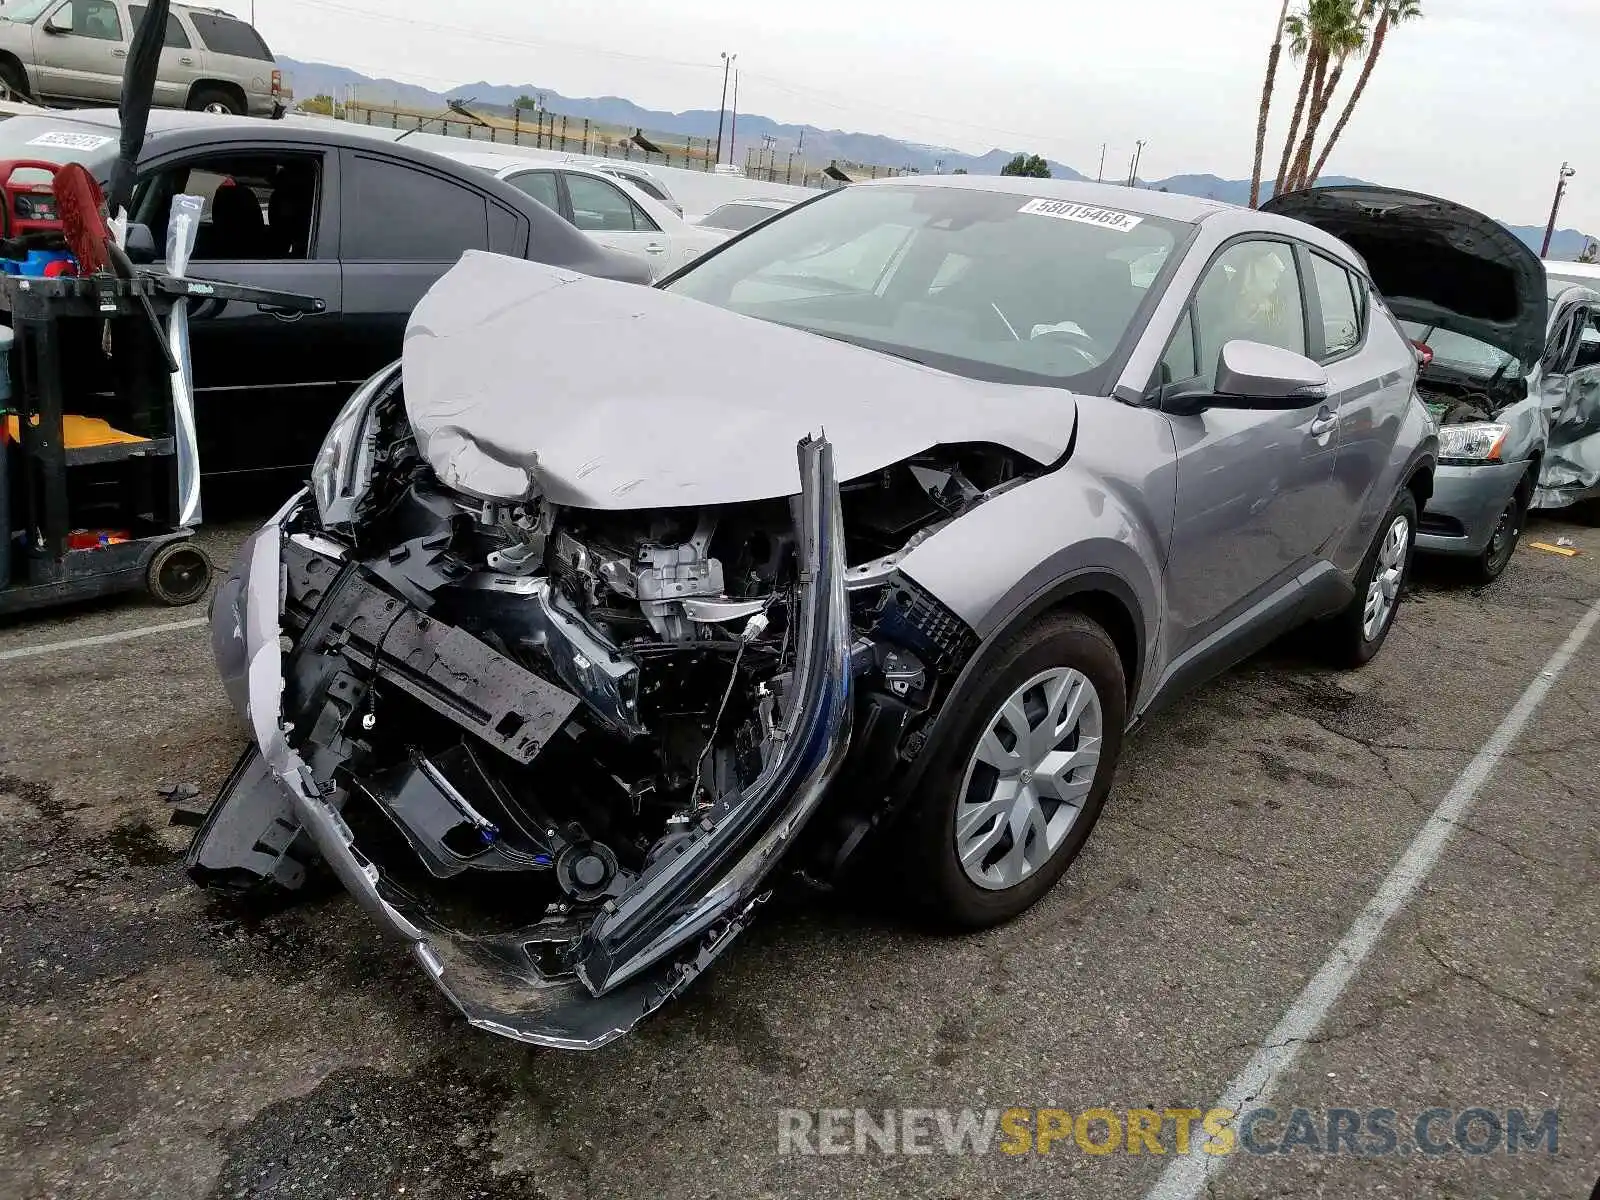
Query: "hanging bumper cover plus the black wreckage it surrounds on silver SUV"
189 401 851 1048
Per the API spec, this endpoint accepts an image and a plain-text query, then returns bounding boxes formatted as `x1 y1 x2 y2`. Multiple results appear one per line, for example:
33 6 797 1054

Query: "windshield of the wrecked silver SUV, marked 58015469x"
666 184 1190 389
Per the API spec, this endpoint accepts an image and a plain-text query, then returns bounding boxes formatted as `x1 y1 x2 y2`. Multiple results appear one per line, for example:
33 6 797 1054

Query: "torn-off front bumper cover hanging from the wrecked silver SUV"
189 438 851 1050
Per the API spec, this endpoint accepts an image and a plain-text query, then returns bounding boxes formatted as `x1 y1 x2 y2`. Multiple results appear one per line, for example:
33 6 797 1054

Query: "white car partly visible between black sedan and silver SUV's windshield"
450 152 723 278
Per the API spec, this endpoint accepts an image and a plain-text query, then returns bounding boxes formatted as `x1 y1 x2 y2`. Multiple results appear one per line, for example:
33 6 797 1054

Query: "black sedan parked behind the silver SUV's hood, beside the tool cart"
0 109 648 494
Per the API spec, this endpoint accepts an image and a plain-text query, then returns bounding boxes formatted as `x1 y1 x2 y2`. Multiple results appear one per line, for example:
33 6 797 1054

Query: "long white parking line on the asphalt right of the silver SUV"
1146 602 1600 1200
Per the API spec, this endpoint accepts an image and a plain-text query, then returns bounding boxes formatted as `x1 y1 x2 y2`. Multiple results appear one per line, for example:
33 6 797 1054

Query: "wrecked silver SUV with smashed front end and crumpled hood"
189 178 1437 1048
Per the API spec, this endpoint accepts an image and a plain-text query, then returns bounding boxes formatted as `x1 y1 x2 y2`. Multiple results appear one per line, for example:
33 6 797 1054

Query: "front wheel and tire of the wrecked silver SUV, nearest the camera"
907 613 1128 930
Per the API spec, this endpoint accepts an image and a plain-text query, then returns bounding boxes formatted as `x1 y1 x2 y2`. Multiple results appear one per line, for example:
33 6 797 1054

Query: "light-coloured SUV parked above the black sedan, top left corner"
0 0 283 117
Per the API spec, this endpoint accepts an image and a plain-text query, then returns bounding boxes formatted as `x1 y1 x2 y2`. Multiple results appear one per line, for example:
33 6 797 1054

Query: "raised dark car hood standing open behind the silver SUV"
1261 186 1549 370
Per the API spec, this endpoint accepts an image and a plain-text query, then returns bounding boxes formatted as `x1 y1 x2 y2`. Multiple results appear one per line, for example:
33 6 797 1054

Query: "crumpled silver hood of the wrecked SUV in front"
402 251 1077 509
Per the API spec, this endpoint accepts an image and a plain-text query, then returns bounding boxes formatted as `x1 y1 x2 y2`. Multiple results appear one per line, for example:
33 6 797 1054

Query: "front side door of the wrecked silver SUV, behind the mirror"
1162 238 1338 659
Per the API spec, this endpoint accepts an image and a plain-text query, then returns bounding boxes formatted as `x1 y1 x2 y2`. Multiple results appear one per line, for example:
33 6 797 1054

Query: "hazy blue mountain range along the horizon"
278 58 1590 259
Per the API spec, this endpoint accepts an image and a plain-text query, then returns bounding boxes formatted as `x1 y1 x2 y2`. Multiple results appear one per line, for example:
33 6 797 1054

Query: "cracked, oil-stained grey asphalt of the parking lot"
0 520 1600 1200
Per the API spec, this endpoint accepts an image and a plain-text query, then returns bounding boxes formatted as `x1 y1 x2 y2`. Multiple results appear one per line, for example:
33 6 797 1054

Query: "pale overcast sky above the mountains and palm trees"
240 0 1600 234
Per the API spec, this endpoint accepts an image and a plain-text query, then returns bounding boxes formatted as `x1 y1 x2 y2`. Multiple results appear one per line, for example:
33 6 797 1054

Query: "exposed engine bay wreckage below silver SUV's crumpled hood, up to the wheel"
189 379 1040 1046
